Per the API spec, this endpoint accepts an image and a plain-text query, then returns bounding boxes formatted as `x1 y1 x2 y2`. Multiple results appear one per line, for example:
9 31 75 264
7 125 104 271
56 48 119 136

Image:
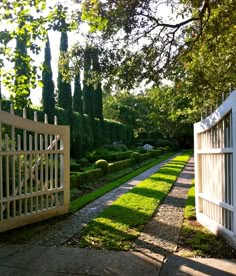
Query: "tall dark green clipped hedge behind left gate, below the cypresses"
2 101 133 159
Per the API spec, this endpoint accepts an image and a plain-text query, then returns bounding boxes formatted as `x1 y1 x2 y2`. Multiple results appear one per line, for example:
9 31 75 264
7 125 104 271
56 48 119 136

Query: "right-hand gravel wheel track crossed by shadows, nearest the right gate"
134 157 194 257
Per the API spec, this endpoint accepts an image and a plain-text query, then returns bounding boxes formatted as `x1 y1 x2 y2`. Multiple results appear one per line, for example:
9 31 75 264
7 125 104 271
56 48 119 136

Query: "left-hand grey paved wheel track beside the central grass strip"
29 154 178 246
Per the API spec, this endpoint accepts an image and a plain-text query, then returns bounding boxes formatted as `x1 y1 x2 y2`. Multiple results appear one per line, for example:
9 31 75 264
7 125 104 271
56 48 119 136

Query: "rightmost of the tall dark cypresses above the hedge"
93 48 103 120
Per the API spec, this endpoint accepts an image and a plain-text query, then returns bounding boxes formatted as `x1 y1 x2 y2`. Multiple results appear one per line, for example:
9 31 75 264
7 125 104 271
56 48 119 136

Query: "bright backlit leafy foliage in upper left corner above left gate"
0 0 75 108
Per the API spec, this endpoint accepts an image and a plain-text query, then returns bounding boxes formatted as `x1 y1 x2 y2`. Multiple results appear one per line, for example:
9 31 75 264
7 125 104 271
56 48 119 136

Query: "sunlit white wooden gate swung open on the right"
194 91 236 248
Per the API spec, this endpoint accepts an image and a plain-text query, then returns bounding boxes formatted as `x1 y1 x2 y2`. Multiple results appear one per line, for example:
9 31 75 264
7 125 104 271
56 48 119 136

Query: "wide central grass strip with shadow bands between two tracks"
79 151 192 250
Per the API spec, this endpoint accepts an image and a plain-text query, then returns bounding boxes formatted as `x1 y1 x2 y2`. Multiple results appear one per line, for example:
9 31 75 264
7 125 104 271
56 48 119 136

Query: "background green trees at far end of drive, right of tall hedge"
104 90 193 147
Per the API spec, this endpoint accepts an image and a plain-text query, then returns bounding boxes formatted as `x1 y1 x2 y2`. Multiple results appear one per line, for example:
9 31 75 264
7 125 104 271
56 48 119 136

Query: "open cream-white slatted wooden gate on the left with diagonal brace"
0 104 70 232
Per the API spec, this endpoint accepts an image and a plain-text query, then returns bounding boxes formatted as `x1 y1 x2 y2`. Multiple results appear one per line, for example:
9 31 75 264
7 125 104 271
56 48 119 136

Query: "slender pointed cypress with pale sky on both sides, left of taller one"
42 36 55 121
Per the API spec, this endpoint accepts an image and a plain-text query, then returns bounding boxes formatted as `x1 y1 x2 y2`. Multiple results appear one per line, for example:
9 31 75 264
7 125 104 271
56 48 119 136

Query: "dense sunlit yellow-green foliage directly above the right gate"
168 0 236 122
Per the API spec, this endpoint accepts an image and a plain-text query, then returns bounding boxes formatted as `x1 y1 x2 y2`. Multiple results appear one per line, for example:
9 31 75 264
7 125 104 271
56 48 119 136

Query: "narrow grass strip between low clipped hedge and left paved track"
70 152 177 213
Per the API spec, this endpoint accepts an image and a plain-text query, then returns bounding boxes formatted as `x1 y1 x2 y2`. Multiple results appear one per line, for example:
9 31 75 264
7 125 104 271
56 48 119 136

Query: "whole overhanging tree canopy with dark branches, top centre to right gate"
78 0 236 122
